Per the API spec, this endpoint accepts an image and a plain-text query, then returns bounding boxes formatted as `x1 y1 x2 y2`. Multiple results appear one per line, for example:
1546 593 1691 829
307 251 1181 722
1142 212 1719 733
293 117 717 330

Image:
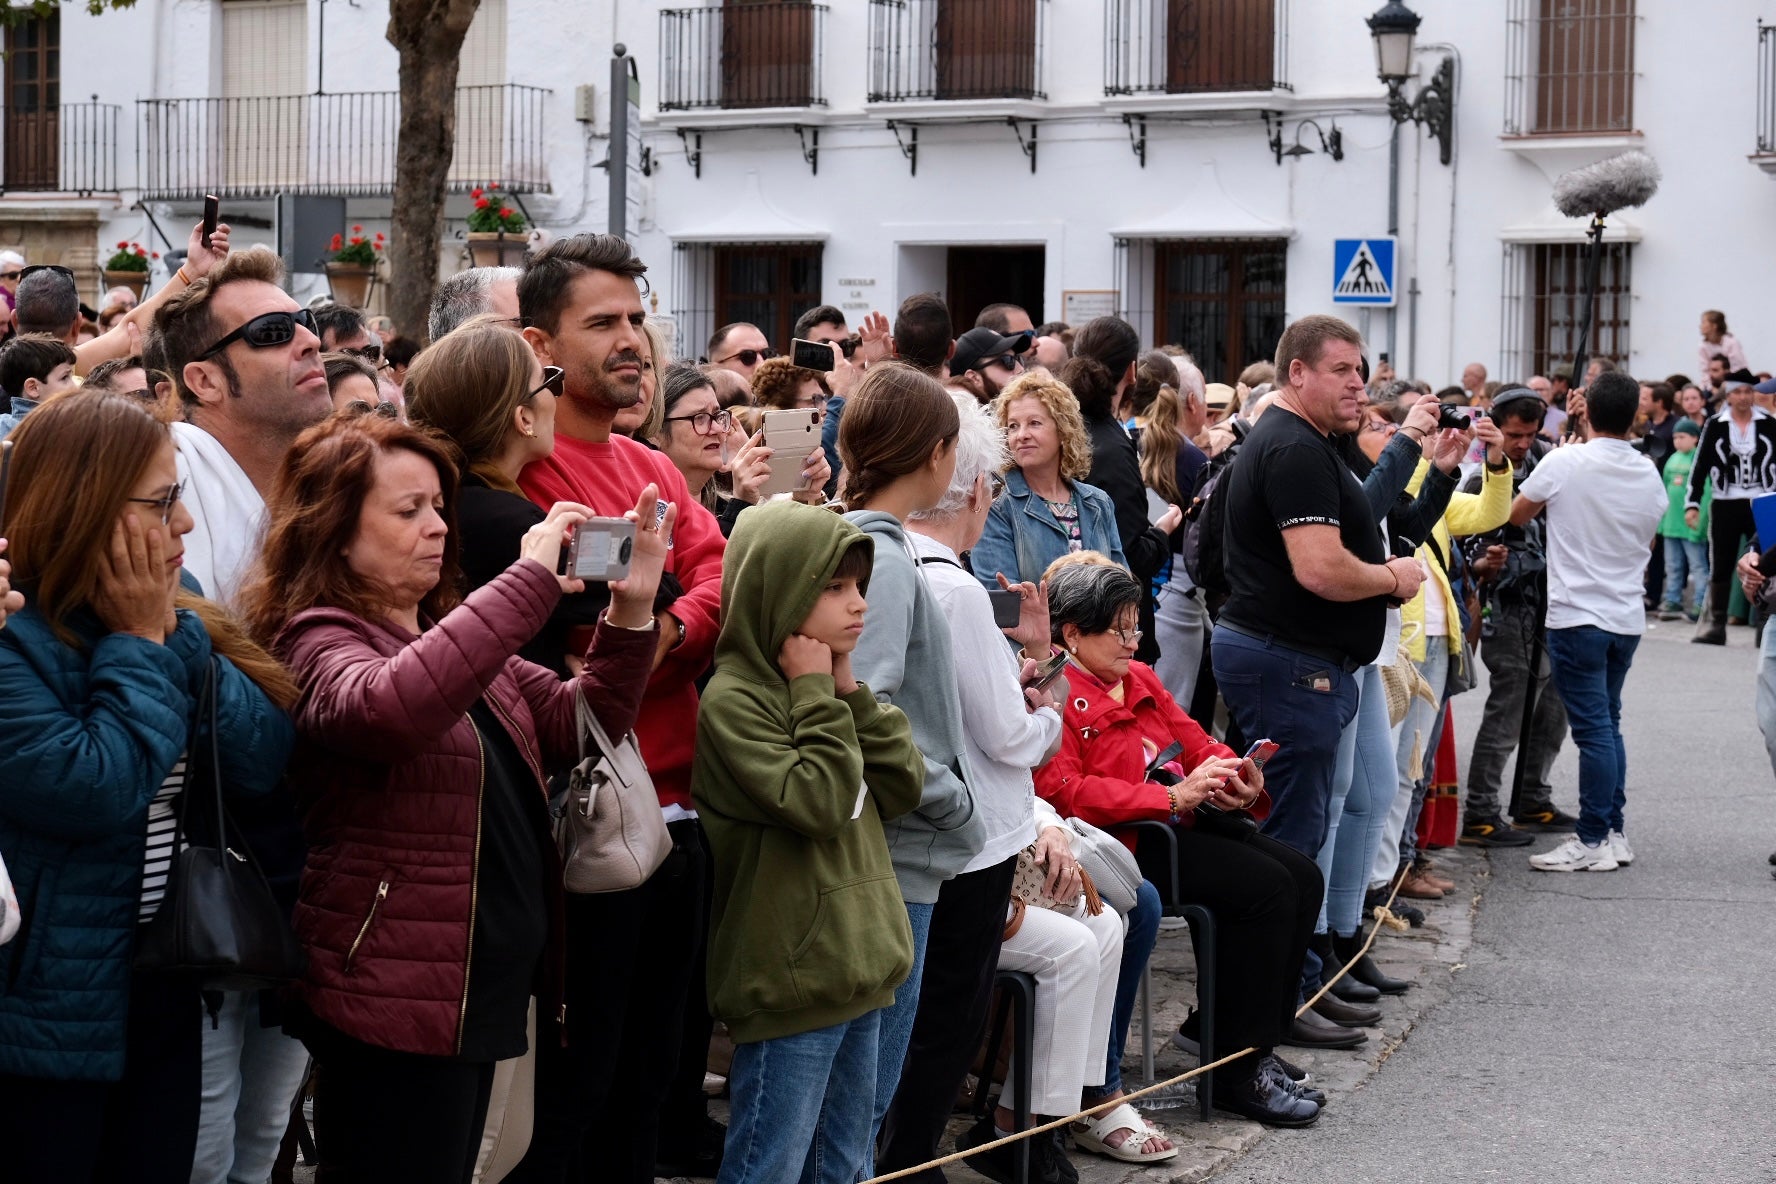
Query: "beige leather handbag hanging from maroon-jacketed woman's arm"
556 696 671 893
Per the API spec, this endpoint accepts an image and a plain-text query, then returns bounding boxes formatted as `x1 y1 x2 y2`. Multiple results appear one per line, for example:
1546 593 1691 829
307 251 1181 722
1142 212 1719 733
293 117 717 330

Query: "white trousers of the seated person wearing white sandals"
998 898 1126 1115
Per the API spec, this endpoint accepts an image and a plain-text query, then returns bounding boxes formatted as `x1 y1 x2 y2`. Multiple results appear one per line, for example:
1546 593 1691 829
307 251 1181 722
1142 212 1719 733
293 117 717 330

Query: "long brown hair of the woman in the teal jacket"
0 391 297 710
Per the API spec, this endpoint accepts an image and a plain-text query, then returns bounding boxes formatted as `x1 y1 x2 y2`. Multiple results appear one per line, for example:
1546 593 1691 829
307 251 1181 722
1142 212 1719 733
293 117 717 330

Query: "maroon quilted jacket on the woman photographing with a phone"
277 559 657 1056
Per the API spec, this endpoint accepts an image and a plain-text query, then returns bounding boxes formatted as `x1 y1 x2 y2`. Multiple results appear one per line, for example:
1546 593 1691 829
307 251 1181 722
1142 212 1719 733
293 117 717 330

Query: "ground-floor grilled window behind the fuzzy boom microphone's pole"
1499 243 1634 382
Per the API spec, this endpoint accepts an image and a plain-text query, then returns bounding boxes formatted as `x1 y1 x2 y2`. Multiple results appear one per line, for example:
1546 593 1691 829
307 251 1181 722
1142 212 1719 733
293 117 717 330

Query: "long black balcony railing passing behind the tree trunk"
137 83 549 201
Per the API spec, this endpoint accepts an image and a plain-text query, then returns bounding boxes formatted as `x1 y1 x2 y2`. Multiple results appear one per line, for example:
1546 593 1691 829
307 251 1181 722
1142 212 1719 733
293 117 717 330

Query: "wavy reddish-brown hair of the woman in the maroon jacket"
240 411 460 646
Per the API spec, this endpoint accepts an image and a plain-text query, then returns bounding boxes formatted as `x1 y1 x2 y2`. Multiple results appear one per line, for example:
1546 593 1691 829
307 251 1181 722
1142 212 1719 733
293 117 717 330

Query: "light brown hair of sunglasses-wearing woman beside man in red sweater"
401 316 536 493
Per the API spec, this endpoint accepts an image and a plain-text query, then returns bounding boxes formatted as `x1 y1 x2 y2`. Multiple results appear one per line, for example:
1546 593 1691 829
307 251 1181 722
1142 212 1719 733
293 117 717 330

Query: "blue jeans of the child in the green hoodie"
716 1010 883 1184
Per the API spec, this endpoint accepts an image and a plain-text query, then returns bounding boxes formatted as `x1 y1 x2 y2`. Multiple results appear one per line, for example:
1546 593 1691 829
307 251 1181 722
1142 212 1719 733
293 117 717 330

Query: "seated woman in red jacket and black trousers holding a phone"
1035 556 1325 1127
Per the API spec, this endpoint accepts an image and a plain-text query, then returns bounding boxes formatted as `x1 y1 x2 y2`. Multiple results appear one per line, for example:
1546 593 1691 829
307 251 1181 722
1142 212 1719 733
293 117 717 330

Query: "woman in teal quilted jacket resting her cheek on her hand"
0 392 297 1184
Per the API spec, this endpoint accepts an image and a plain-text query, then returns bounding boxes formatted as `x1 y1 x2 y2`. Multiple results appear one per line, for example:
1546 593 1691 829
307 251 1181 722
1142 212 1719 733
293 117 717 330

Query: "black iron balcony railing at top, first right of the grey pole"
661 0 828 112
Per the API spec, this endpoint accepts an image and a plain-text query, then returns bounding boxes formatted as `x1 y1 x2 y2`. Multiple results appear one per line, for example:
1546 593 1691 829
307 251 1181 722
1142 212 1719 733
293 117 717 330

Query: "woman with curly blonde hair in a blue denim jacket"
970 369 1124 589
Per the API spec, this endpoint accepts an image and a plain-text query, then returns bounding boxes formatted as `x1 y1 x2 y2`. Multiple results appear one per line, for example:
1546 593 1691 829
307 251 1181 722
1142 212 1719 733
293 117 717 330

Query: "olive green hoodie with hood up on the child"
691 502 925 1044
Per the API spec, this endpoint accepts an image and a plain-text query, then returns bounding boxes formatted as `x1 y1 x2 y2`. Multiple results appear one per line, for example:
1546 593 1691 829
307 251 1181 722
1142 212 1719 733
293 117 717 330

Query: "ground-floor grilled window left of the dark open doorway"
673 243 826 359
